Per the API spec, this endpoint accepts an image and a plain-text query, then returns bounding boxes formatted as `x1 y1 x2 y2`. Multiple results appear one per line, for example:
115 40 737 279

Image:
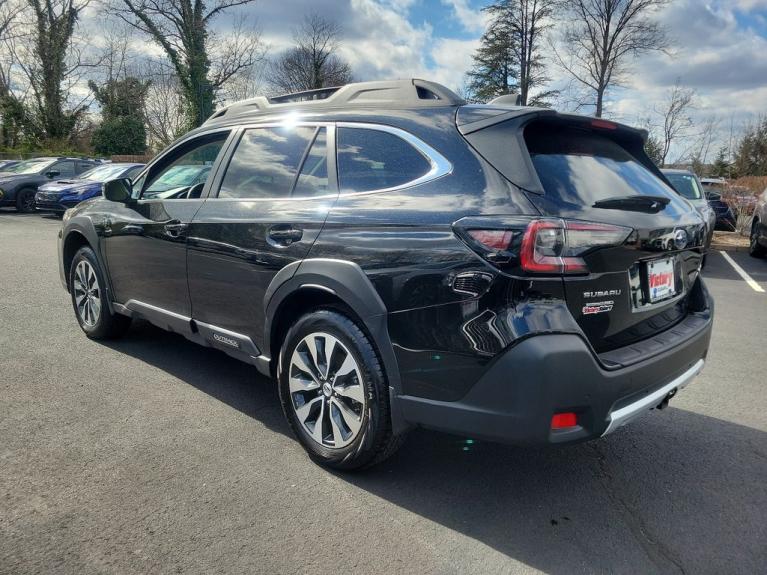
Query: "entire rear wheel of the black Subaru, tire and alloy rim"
278 310 404 471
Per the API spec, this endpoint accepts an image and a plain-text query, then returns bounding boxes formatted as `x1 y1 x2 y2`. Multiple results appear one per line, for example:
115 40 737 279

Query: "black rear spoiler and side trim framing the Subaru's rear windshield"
455 105 667 194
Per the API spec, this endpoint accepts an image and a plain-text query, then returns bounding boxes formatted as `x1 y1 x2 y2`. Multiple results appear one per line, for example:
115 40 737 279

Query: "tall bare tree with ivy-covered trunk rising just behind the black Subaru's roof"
113 0 261 126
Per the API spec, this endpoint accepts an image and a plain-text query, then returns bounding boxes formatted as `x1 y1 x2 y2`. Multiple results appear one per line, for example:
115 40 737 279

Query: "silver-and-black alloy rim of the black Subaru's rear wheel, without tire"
288 332 366 449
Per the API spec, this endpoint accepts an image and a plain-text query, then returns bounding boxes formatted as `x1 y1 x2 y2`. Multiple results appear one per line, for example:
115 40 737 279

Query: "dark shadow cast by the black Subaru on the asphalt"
99 321 767 574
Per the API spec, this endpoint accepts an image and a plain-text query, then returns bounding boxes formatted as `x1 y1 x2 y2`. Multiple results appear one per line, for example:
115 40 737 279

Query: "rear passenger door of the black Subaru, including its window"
188 124 338 355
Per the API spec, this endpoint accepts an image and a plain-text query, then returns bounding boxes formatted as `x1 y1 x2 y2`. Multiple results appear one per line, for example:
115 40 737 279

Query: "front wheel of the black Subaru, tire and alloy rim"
69 247 131 339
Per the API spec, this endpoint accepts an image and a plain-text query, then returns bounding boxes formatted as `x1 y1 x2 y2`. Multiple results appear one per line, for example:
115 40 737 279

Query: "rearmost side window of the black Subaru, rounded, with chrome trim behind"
337 128 431 192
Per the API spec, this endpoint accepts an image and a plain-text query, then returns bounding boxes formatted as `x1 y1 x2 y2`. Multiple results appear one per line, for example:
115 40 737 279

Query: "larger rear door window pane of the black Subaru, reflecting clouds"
218 126 315 198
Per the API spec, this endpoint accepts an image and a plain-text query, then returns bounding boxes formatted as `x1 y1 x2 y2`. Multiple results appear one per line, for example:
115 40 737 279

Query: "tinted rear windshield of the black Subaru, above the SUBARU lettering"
525 128 671 206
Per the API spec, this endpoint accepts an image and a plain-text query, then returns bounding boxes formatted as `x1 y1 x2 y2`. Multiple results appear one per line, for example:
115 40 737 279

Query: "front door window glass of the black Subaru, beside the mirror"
142 132 229 200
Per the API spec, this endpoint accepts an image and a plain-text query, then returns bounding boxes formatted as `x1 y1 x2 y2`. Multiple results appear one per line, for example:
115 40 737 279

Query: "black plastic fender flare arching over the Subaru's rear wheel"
264 258 406 433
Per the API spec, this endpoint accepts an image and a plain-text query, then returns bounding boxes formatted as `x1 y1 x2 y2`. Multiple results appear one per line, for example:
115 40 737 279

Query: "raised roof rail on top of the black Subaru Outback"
205 78 466 124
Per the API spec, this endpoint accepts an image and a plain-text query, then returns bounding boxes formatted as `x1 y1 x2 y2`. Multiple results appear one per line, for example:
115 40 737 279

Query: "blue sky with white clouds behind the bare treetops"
103 0 767 161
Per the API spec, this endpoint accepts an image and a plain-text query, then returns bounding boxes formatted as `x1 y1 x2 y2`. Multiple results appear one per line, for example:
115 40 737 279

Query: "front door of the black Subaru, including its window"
103 130 230 329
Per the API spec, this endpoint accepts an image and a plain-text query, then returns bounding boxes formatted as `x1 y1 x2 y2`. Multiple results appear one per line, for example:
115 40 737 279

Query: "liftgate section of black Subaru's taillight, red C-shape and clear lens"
519 219 631 274
